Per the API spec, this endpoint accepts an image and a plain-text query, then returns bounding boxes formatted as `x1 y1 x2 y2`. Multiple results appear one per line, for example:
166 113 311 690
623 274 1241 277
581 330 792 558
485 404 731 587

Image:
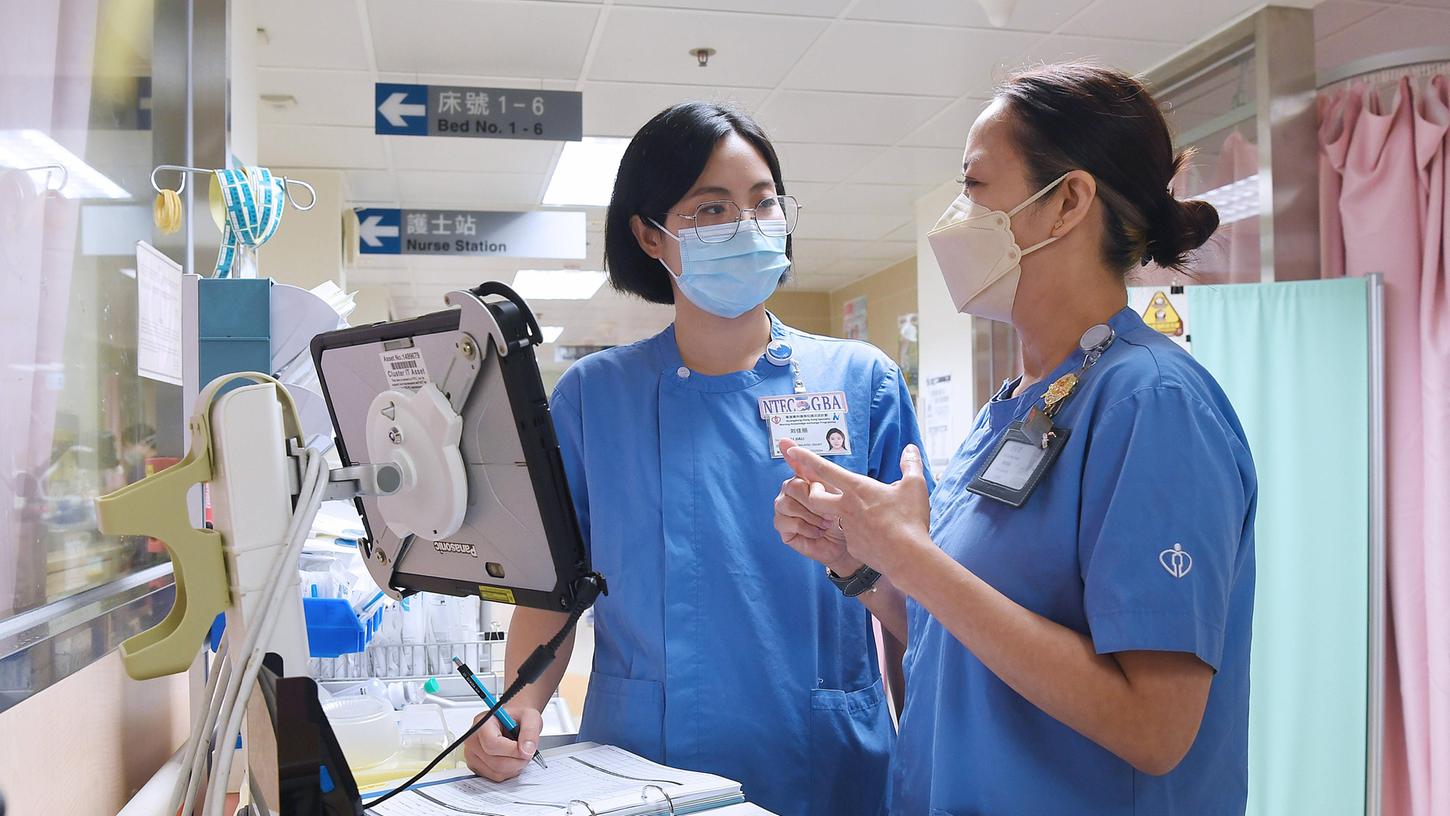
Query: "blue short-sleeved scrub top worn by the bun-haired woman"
892 309 1257 816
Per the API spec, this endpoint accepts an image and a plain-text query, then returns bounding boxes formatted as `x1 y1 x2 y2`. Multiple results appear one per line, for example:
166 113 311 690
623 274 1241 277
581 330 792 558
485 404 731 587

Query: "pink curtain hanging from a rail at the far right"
1320 77 1450 816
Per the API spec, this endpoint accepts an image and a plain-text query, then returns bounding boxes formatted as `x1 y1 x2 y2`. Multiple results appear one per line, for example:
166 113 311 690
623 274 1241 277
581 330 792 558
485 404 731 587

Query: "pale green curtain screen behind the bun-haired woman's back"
1188 278 1370 816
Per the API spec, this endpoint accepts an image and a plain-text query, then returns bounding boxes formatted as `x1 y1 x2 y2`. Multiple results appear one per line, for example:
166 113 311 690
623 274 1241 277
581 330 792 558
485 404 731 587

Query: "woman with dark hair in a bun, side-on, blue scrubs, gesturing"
777 65 1264 816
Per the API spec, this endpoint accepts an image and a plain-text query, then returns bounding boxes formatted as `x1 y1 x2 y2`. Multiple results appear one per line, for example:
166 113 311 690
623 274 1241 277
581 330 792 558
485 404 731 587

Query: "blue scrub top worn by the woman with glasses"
552 317 921 816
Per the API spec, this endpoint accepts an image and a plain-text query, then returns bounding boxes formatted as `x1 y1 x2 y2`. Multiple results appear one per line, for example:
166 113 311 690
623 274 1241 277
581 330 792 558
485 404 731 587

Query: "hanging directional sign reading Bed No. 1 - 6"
373 83 584 142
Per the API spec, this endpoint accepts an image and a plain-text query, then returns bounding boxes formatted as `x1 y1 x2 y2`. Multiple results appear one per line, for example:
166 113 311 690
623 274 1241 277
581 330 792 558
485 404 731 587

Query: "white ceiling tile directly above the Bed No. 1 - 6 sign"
374 0 599 78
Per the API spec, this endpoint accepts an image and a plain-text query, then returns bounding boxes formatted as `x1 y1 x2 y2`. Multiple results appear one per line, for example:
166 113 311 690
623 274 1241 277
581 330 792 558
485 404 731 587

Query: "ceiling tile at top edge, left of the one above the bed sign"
257 0 371 71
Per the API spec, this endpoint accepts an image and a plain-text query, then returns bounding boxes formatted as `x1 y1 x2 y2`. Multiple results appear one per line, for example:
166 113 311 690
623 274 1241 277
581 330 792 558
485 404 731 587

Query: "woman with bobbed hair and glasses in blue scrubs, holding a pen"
467 103 919 816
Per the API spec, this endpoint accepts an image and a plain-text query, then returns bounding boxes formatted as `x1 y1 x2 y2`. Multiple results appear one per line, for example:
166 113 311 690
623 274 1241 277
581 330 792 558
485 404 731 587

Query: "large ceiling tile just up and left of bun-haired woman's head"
784 22 1038 96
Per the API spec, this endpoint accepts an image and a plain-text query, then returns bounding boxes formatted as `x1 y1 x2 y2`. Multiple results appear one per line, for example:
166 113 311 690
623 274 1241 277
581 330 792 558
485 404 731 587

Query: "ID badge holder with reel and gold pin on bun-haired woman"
967 323 1117 507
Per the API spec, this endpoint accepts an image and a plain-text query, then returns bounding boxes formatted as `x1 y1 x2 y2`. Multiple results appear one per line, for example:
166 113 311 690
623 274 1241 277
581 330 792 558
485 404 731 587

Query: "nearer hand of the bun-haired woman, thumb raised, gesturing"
780 439 932 575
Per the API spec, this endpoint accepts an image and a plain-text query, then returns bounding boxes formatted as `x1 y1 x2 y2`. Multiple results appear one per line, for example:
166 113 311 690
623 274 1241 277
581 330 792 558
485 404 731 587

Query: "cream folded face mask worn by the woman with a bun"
927 174 1067 323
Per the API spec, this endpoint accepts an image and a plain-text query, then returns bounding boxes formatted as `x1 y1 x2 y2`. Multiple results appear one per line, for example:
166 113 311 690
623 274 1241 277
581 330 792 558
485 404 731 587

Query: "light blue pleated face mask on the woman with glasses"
650 219 790 317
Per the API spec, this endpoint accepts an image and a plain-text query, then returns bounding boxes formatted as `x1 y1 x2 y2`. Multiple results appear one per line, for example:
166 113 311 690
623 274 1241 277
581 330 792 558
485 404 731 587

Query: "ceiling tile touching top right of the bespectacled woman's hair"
757 91 950 145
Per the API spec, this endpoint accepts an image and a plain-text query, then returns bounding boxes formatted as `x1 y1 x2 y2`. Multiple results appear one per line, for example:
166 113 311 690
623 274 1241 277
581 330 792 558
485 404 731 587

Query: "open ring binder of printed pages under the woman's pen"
363 742 745 816
